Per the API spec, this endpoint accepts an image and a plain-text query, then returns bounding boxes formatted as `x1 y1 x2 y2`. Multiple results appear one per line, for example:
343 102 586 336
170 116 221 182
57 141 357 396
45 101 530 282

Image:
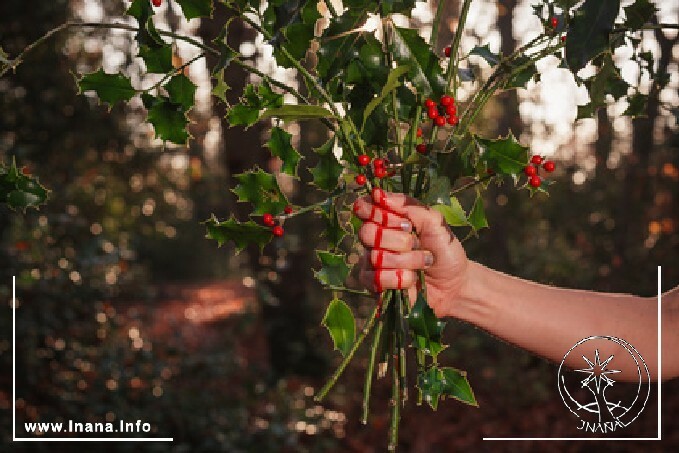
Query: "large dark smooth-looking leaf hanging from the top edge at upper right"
566 0 620 74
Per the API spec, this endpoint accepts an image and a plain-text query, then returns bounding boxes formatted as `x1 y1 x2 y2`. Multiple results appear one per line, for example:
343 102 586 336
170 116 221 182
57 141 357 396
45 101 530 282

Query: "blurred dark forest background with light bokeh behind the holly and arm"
0 0 679 452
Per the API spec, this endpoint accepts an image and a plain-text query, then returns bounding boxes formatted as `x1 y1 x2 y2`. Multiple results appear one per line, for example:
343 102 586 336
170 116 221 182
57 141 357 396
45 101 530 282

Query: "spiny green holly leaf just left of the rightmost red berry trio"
474 132 528 175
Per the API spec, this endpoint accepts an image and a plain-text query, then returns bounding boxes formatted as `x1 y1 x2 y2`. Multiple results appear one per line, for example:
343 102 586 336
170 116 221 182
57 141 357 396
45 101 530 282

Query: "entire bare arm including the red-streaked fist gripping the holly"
354 189 679 381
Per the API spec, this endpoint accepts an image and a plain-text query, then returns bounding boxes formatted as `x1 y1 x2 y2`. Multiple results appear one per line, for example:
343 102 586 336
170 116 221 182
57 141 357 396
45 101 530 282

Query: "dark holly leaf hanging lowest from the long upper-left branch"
144 95 189 145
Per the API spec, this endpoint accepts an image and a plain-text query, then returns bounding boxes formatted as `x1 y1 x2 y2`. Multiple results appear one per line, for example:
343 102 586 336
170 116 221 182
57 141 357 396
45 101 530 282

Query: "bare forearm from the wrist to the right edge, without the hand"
451 262 679 380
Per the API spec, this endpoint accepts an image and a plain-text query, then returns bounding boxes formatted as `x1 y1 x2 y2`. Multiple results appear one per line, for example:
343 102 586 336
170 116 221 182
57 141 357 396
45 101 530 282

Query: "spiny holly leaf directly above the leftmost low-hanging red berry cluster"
232 168 289 215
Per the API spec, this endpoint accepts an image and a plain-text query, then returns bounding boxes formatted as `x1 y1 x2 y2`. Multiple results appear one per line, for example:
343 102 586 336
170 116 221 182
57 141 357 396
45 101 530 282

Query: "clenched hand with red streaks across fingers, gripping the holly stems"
354 188 469 317
